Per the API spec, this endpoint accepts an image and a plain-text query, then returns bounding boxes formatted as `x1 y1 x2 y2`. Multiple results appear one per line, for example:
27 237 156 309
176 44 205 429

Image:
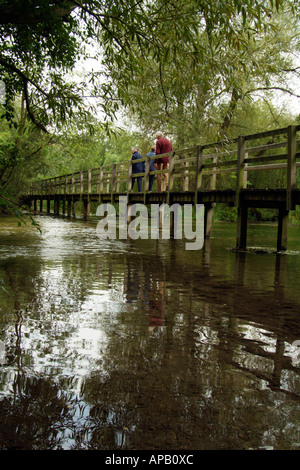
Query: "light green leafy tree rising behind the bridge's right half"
104 0 300 146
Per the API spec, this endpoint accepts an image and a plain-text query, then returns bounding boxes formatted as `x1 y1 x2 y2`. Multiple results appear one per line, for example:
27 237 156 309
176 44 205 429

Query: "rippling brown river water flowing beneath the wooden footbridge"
0 216 300 450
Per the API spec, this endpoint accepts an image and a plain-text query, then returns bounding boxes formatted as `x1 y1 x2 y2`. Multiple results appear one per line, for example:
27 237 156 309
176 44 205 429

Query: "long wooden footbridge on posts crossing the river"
26 126 300 251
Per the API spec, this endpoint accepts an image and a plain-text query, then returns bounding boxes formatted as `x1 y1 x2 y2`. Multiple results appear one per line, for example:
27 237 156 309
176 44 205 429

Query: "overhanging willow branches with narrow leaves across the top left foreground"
0 0 287 132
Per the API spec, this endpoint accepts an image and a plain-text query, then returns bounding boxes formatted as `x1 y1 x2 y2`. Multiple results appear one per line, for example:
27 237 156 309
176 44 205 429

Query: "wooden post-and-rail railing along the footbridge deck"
30 126 300 204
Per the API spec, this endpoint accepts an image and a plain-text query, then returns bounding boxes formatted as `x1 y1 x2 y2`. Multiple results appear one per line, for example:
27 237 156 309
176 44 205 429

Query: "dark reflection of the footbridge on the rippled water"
77 239 300 403
